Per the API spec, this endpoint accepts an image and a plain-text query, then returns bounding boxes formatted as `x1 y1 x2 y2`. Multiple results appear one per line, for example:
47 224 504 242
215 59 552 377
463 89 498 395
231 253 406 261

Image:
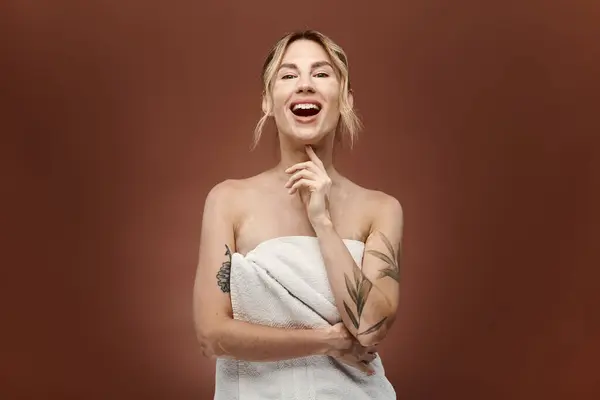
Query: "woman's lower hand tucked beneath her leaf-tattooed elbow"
327 322 377 375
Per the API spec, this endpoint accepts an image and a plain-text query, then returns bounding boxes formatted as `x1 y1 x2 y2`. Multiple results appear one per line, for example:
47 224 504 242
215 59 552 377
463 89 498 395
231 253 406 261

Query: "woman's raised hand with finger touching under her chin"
285 146 331 226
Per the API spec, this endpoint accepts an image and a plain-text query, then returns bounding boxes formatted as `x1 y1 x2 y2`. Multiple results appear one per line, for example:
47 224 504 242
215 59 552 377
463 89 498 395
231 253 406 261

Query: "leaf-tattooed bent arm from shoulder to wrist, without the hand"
313 193 403 346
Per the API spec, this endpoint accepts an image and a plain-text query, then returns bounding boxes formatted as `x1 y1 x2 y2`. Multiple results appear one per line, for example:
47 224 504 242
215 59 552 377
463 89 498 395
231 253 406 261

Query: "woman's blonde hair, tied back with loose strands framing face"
251 30 362 149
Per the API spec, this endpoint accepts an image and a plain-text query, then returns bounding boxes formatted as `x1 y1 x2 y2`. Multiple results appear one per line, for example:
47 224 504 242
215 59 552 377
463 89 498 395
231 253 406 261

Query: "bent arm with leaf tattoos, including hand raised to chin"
285 146 403 347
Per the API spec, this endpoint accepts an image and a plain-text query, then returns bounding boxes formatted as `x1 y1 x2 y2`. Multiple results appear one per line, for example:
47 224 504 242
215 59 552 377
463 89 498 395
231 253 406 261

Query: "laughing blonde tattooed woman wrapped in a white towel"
194 31 403 399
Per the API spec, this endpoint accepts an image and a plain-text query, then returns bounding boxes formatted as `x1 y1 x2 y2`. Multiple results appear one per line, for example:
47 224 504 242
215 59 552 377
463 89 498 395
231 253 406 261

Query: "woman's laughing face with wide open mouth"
271 40 340 145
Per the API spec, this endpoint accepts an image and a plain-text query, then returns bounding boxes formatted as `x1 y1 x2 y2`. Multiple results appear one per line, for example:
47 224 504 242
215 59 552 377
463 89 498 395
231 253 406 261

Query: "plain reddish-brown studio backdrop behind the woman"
0 0 600 400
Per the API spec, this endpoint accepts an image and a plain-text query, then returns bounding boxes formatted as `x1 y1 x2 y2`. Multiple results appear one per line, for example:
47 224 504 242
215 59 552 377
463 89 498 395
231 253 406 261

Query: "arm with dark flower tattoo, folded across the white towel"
194 181 352 361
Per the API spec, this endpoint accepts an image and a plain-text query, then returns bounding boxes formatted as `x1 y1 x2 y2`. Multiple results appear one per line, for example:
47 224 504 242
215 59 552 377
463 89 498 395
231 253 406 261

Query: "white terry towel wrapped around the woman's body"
214 236 396 400
